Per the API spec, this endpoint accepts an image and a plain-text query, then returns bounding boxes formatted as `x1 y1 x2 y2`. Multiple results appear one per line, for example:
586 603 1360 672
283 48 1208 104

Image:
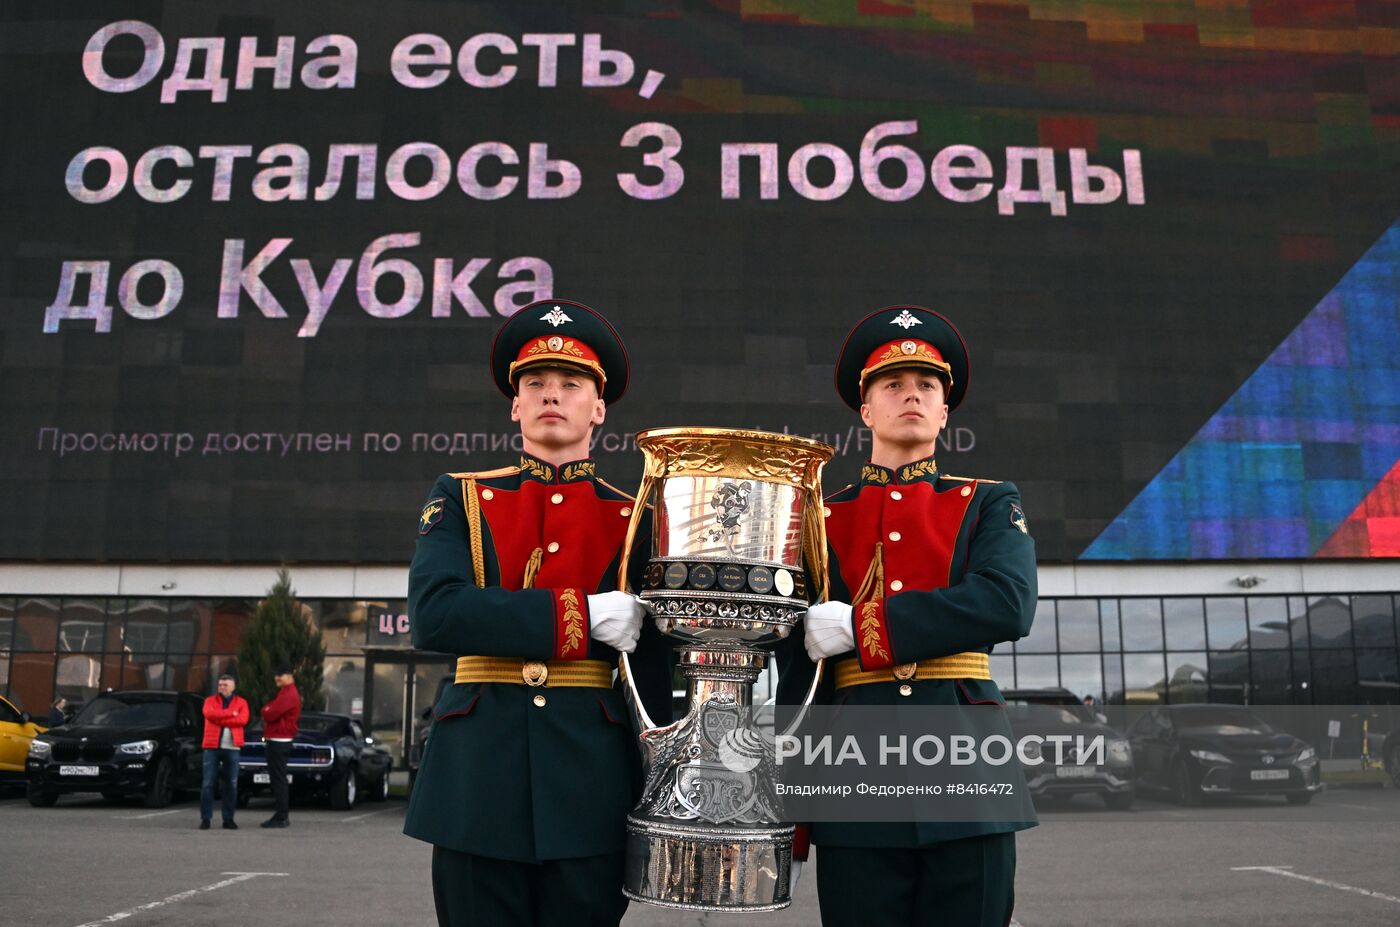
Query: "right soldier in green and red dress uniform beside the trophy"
778 305 1036 927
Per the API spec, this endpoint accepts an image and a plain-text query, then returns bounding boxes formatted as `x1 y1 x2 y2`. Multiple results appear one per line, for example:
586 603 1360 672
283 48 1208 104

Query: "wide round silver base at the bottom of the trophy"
623 815 795 913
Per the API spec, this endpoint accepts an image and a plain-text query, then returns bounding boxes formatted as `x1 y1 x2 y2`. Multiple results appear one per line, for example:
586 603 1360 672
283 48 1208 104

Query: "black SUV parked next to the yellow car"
24 690 203 808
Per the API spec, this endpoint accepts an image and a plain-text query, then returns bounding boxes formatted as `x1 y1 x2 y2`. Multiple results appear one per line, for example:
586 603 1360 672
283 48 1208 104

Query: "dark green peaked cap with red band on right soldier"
836 305 972 412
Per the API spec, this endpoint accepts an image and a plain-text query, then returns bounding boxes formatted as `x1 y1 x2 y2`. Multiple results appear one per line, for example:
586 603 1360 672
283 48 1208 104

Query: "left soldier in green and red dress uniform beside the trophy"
403 300 671 926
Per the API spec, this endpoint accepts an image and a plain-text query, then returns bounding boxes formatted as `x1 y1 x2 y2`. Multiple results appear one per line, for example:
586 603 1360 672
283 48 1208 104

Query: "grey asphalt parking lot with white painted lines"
0 788 1400 927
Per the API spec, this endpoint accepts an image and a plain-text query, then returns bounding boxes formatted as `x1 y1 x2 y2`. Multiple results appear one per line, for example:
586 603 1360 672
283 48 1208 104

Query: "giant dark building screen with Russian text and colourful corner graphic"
0 0 1400 563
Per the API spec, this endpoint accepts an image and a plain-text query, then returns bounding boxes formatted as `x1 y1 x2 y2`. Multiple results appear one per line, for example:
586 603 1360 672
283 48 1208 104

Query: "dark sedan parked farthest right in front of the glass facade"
1128 704 1322 805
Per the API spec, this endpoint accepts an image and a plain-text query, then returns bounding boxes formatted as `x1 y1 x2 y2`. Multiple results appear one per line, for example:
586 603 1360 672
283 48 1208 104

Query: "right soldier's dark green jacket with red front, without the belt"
777 458 1036 847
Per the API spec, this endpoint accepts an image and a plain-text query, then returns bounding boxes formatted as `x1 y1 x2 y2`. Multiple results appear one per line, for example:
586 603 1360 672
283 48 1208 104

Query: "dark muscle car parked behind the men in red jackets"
238 711 393 811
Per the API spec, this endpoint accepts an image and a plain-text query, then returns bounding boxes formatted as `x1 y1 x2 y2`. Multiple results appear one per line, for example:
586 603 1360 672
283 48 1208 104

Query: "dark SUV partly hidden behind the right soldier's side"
1002 689 1134 811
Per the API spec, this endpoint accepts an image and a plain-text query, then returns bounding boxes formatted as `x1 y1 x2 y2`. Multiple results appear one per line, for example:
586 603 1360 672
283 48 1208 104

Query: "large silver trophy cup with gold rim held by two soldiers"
622 428 833 912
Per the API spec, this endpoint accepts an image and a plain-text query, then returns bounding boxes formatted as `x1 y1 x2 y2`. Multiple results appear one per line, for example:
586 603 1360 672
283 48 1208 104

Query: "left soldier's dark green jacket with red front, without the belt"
403 456 671 863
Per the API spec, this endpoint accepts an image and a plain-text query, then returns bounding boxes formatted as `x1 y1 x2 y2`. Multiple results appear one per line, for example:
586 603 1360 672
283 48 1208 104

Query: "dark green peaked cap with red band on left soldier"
491 300 629 403
